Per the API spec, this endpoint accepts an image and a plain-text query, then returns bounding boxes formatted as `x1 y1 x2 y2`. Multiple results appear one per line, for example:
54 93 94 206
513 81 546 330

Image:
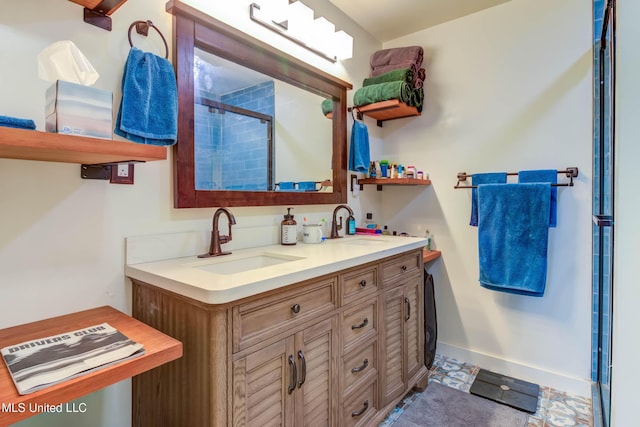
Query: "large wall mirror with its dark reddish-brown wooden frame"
167 0 352 208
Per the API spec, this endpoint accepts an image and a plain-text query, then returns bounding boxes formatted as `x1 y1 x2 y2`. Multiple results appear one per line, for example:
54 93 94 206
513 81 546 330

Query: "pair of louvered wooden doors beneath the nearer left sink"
231 316 338 426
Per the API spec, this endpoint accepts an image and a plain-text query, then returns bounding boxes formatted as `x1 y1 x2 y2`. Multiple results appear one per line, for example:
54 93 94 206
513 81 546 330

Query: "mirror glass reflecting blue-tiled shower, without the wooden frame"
194 48 333 191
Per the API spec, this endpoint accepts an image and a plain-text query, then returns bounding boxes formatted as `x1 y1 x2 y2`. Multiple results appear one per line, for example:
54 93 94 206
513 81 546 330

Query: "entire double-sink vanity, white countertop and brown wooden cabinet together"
126 235 428 426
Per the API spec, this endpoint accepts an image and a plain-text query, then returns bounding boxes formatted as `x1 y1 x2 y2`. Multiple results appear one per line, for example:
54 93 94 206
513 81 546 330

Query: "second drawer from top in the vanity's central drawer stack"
342 298 378 352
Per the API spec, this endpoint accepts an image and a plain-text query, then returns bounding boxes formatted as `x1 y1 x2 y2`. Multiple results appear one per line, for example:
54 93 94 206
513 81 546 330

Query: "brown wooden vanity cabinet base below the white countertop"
132 250 428 427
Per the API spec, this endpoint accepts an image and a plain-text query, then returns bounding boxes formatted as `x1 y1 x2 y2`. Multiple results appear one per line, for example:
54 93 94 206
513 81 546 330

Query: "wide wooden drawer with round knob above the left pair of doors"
232 276 337 352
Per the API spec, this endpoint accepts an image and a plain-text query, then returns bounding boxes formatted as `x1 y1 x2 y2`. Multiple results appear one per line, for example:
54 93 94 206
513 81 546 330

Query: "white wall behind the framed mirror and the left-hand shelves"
0 0 380 427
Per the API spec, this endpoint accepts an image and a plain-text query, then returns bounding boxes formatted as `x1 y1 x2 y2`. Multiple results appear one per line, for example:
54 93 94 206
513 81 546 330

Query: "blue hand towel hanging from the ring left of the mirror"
114 47 178 145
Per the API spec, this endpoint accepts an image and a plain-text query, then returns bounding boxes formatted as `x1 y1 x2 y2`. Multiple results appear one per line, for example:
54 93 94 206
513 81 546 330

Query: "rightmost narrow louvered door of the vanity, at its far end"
404 278 424 381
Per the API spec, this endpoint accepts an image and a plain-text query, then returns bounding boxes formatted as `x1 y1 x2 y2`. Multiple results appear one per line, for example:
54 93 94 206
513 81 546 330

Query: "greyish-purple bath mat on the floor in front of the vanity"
393 382 529 427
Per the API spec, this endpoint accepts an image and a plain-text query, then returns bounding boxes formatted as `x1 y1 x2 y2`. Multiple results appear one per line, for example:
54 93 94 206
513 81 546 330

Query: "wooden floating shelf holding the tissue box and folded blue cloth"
0 127 167 165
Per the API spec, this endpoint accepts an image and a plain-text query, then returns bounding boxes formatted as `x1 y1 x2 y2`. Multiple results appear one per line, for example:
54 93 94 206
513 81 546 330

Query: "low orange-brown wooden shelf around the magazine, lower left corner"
0 306 182 426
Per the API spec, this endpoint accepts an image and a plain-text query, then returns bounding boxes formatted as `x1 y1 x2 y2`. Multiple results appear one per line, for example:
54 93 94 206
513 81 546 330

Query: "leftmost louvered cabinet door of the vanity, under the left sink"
233 336 298 427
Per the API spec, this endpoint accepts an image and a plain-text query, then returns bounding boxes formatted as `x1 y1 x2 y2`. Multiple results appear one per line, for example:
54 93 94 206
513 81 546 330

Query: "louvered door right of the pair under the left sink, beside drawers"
294 316 339 427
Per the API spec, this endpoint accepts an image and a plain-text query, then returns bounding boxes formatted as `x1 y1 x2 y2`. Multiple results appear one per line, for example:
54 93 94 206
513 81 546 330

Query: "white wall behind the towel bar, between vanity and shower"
372 0 592 396
